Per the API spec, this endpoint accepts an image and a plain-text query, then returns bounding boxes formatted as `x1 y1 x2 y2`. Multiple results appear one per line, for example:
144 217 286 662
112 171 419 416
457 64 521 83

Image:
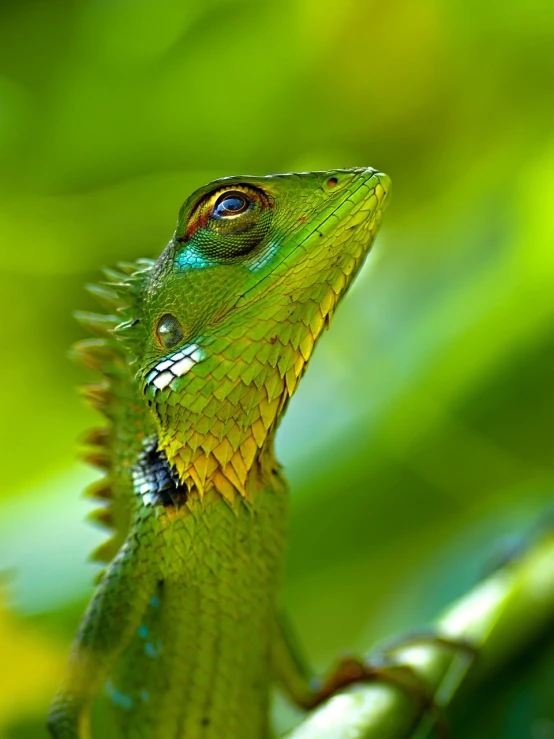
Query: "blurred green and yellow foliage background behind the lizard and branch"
0 0 554 739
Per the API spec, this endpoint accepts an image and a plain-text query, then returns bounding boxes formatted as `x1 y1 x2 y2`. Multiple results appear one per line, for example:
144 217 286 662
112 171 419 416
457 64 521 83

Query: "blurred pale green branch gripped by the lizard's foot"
286 536 554 739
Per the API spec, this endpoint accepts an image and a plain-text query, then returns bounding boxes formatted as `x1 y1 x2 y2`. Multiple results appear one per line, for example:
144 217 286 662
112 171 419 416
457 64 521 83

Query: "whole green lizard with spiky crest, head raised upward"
49 168 390 739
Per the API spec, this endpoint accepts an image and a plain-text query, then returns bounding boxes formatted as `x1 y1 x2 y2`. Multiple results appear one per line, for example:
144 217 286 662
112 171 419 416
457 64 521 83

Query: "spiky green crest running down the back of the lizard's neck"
71 259 153 563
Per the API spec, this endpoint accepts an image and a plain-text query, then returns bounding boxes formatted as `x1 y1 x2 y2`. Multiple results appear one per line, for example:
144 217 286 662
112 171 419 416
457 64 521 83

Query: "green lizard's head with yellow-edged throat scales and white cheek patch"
124 168 390 498
